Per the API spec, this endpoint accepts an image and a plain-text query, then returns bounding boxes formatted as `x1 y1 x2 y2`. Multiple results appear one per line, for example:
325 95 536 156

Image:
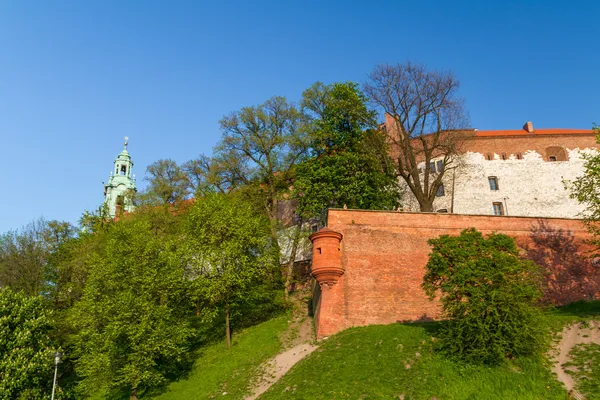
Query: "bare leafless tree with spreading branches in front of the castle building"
364 62 468 211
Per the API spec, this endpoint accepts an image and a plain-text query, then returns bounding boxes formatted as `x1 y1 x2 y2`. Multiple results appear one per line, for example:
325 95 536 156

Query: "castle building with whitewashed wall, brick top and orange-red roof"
386 117 600 218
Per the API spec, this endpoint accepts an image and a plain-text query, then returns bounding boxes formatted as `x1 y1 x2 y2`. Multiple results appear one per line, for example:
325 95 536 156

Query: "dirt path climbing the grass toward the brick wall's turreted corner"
245 290 317 400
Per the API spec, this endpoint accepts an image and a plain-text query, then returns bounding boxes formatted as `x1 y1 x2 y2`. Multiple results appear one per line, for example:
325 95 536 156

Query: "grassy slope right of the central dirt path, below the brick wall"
261 302 600 400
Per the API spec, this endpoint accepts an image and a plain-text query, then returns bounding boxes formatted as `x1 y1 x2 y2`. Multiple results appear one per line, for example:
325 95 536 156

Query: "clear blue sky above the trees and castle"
0 0 600 232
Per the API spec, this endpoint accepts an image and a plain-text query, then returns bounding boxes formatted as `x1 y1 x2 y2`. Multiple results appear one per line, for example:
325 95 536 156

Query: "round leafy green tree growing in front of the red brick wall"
423 229 544 364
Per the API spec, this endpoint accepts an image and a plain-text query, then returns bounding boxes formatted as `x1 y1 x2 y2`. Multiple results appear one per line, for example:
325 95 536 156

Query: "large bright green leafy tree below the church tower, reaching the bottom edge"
70 207 193 399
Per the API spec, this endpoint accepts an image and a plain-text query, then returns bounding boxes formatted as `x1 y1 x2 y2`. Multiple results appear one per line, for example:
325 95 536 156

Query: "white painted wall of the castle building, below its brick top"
404 149 596 218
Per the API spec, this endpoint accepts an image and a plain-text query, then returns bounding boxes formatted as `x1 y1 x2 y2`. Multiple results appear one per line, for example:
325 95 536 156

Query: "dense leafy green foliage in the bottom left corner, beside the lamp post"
0 288 53 400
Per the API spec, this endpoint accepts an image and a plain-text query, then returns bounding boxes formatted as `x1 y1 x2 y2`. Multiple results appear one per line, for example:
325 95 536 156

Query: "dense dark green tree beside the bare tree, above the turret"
294 82 400 217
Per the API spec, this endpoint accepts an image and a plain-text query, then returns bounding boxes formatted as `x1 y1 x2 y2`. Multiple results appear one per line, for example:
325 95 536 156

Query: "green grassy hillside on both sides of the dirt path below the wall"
146 302 600 400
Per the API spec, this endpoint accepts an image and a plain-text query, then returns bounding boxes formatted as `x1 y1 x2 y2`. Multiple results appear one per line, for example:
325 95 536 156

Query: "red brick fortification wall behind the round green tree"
316 210 588 338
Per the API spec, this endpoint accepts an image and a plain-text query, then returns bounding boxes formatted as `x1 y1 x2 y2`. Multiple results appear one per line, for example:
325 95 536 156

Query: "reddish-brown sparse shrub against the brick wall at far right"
526 220 600 305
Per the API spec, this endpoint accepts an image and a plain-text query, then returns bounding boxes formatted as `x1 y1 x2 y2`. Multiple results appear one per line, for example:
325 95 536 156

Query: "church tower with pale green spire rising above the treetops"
103 136 136 218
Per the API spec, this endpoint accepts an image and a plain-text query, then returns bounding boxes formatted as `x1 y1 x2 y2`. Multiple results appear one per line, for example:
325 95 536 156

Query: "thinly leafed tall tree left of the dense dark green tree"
200 97 307 239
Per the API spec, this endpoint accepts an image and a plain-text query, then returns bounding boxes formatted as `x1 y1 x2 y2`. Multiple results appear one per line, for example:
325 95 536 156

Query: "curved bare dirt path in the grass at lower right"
552 321 600 399
